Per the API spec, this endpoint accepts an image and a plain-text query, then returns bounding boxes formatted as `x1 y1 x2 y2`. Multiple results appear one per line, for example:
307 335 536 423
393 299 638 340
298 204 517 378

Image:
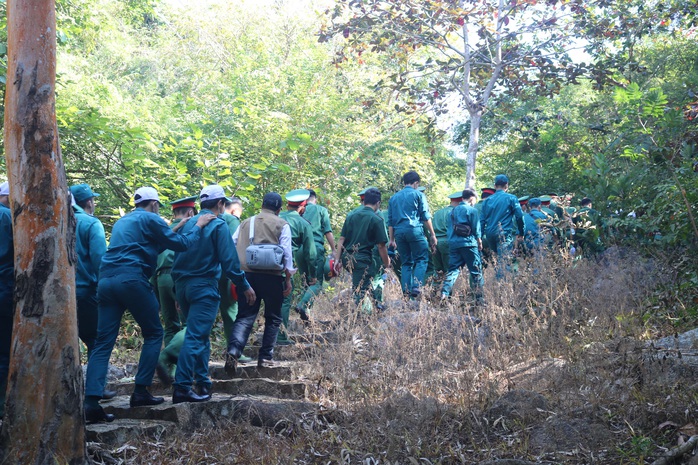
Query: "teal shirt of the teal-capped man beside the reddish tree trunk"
73 205 107 289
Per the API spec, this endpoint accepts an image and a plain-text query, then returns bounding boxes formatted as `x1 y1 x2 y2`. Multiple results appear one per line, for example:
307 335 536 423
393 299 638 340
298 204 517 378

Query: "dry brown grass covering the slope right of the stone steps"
98 246 698 464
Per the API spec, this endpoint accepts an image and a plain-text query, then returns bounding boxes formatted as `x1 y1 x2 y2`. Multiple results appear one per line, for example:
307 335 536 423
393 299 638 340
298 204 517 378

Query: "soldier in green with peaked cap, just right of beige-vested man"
276 189 317 345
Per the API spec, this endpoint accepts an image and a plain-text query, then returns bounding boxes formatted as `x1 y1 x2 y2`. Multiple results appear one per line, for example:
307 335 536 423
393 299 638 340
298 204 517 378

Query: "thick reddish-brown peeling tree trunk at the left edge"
0 0 87 464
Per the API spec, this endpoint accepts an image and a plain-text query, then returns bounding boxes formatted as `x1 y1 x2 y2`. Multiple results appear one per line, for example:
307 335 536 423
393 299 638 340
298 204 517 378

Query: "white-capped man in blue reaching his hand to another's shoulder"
85 187 215 423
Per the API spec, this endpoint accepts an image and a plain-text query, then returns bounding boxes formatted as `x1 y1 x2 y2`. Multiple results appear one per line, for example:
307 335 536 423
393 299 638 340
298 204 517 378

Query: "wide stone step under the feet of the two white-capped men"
100 393 318 434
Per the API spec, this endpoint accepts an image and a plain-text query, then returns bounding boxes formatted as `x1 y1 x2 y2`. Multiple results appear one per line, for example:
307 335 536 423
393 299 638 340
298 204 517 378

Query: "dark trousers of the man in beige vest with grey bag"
228 272 284 360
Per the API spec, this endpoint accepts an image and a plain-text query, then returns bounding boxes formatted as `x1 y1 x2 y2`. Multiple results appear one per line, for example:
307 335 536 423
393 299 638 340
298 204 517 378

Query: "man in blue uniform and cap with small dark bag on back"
441 189 484 303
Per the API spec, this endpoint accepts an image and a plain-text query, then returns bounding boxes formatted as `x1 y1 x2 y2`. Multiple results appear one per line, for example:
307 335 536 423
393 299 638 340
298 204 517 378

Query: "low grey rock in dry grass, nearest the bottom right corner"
529 416 612 453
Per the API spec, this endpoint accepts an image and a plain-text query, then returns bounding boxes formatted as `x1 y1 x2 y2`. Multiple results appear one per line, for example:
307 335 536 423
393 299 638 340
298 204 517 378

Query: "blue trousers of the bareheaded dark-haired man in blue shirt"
395 229 429 292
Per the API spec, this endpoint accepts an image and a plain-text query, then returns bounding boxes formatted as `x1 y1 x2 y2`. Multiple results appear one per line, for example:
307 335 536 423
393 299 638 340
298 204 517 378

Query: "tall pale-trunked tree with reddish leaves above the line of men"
320 0 584 187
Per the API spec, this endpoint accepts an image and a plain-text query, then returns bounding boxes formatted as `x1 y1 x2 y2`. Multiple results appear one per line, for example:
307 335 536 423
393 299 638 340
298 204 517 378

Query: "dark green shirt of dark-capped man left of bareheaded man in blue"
342 207 388 262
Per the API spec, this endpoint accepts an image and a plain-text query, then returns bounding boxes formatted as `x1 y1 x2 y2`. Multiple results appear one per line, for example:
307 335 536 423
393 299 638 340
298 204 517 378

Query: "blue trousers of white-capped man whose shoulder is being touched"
174 278 221 390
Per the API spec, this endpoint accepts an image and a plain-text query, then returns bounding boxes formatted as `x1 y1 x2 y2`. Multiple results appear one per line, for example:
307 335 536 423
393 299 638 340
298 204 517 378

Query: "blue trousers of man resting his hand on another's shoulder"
85 270 163 396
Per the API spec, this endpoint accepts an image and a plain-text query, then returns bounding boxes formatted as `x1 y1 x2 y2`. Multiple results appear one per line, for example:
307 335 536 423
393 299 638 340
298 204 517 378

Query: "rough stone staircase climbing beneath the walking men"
86 331 338 446
